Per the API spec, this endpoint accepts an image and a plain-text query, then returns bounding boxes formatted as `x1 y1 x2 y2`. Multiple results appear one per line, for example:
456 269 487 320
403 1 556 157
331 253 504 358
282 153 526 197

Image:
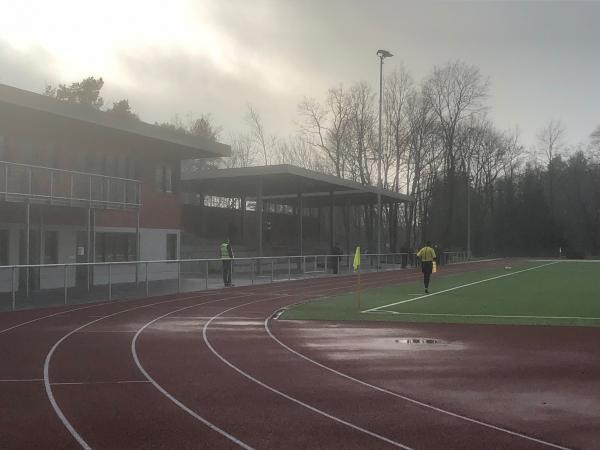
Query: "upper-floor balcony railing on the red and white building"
0 161 142 209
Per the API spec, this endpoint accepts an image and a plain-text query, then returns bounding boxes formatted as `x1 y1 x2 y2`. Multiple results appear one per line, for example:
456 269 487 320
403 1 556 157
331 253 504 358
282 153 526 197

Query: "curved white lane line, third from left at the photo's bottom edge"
202 299 411 450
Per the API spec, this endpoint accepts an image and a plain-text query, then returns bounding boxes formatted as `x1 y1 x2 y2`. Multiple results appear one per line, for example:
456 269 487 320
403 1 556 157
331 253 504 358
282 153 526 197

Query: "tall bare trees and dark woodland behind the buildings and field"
46 66 600 257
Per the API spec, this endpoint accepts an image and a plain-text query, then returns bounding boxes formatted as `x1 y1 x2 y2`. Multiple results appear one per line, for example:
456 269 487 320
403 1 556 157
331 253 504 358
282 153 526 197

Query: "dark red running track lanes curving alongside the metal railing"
0 262 600 449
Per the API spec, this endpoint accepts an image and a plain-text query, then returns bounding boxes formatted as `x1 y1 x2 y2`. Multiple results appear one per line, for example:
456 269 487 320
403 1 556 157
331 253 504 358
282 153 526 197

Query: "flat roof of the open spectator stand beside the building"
182 164 413 207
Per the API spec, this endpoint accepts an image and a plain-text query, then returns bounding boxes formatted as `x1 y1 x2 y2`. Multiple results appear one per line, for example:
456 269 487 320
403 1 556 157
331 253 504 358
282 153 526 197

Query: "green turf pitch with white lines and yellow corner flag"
280 261 600 326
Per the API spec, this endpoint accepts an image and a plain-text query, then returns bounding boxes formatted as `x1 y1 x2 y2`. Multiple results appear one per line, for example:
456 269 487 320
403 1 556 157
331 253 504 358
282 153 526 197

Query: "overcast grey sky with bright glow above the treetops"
0 0 600 149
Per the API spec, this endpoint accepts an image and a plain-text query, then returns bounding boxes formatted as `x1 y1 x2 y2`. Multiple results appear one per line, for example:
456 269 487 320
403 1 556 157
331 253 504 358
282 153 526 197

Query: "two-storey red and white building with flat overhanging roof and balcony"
0 84 230 292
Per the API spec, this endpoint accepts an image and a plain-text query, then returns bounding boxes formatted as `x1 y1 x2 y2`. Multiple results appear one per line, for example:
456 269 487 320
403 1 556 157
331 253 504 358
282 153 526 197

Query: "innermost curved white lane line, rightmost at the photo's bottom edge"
264 315 570 450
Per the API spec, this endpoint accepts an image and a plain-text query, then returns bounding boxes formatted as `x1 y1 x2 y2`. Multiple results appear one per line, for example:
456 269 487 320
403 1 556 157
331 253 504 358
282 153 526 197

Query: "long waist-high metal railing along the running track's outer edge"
0 252 467 311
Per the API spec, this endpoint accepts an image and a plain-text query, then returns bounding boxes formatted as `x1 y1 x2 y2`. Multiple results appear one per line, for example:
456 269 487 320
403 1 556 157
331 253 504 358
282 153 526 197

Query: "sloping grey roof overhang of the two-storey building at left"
0 84 231 159
